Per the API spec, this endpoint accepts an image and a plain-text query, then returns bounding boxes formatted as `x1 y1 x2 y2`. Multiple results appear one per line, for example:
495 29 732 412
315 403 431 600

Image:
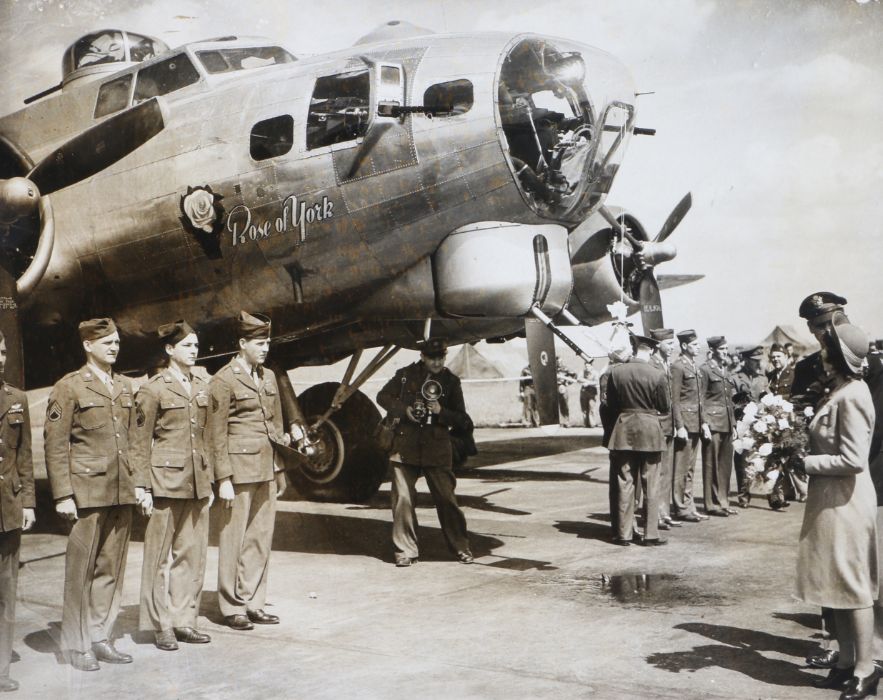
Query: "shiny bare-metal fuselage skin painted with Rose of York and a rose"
0 34 634 387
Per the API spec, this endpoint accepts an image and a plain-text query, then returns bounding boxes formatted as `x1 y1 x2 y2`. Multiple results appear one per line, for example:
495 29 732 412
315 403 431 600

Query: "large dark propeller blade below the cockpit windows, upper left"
28 98 165 195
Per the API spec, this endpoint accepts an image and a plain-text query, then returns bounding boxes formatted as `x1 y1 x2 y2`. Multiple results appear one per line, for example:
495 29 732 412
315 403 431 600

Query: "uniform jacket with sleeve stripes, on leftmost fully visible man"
43 365 139 508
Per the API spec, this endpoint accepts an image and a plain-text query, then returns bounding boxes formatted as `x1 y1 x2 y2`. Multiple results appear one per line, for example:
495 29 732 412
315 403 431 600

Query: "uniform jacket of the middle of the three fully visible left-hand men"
132 369 213 498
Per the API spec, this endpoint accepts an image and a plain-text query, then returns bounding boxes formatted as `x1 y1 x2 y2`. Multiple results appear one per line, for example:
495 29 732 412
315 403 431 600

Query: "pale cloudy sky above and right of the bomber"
0 0 883 342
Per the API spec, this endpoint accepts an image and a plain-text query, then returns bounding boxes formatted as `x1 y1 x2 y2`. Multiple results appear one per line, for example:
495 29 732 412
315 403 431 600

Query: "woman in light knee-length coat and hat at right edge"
797 324 880 700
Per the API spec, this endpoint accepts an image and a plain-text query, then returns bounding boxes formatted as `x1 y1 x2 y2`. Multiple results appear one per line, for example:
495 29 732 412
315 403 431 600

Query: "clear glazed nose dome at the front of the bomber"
497 37 635 219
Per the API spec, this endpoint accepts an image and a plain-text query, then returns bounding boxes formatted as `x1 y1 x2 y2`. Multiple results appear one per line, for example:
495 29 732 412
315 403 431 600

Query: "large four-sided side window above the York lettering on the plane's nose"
307 68 371 149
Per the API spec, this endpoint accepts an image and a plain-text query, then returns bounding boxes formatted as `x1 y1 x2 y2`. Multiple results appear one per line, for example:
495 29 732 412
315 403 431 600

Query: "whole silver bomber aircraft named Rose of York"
0 22 694 500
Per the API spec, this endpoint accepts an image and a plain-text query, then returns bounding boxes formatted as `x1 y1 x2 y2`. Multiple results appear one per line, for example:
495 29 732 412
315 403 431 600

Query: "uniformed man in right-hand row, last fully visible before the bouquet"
699 335 739 517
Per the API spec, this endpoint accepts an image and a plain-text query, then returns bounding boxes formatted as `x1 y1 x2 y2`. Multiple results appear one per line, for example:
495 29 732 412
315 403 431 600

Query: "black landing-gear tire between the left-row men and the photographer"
286 382 388 503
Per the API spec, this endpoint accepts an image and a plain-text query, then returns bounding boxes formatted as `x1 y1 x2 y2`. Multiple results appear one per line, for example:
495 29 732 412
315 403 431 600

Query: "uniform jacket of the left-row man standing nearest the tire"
208 358 285 484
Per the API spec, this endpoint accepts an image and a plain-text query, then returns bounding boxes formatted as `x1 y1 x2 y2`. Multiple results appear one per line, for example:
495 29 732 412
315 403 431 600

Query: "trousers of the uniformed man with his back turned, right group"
610 450 662 541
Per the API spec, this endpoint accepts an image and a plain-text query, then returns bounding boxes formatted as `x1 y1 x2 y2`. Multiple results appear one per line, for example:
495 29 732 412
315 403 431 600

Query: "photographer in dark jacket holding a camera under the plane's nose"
377 338 473 566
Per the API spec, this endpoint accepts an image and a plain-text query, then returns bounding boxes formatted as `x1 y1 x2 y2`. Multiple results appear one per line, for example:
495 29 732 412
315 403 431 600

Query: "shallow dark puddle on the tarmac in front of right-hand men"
524 573 729 608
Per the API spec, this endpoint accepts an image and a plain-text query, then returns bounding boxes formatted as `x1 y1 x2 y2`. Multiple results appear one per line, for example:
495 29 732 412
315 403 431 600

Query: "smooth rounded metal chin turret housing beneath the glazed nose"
433 221 573 318
